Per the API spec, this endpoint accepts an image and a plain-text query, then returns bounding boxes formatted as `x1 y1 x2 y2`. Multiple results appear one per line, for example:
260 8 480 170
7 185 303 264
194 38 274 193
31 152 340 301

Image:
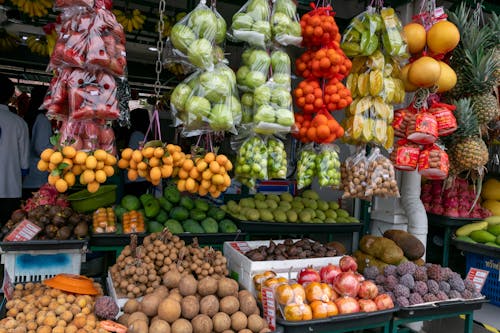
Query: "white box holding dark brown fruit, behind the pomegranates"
223 240 341 293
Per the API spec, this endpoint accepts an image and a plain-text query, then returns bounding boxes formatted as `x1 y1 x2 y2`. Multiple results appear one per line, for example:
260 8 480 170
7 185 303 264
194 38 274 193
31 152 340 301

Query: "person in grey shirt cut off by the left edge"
0 75 29 224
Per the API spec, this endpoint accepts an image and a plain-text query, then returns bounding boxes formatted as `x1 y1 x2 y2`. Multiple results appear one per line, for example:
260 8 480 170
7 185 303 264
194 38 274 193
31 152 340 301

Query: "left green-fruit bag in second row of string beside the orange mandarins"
236 47 271 92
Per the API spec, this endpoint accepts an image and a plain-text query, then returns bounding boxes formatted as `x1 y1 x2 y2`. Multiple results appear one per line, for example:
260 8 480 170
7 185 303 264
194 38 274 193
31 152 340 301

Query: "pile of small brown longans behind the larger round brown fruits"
110 230 228 298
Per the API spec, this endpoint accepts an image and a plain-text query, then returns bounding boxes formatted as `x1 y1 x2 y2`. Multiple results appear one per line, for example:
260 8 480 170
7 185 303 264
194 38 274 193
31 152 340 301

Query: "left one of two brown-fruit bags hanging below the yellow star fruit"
341 149 368 200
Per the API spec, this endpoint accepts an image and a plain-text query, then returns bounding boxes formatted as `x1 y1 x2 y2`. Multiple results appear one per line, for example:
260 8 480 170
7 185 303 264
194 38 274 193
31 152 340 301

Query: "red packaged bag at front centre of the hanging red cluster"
406 111 438 145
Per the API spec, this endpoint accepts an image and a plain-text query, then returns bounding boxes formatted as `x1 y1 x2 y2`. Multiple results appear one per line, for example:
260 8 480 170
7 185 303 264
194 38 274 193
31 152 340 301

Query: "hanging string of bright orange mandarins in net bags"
294 6 352 143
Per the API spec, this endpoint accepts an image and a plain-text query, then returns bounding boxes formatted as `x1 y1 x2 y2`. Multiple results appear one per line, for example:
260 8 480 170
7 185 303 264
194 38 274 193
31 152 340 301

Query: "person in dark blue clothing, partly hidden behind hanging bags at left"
23 86 52 199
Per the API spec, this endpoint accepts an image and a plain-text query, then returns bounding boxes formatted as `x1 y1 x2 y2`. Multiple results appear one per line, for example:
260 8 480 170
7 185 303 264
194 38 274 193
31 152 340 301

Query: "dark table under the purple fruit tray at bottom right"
390 298 488 333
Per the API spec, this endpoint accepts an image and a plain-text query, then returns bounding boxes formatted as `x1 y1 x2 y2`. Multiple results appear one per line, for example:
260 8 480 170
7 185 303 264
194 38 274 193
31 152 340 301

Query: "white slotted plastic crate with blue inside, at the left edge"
2 249 85 283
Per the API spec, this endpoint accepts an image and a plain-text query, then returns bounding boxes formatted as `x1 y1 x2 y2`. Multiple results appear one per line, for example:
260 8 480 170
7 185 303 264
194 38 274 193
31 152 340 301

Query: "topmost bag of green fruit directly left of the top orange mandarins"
271 0 302 46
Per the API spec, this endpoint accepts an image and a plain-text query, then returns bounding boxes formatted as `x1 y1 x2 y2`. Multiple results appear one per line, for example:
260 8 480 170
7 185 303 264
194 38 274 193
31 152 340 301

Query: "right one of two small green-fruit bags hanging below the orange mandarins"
316 144 341 188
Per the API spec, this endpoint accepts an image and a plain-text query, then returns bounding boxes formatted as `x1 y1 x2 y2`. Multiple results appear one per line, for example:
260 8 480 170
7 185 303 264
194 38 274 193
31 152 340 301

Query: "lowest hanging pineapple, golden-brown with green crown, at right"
446 98 489 174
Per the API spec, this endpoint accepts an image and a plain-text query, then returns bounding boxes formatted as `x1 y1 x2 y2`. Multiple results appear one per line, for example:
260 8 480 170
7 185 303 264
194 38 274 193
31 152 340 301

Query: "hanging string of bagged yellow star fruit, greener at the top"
341 7 407 149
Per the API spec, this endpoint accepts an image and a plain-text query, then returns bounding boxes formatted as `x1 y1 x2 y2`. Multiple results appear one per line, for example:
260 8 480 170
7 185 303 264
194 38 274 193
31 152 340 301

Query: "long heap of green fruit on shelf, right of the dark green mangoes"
221 190 359 223
